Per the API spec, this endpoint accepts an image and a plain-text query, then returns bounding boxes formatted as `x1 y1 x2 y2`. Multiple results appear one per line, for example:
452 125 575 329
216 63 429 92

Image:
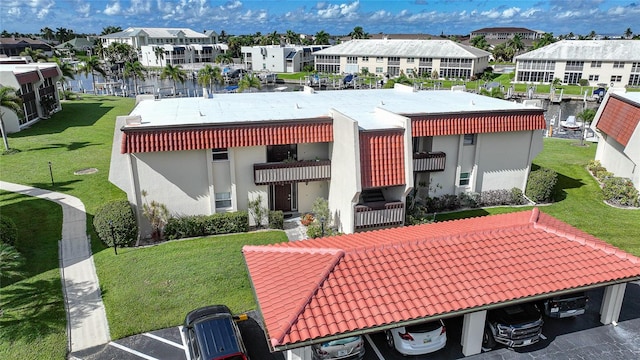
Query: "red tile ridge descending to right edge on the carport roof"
531 208 640 264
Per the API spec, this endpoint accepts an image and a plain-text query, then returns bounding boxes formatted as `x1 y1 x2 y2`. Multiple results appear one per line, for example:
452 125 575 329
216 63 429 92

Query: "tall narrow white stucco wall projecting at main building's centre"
328 109 362 234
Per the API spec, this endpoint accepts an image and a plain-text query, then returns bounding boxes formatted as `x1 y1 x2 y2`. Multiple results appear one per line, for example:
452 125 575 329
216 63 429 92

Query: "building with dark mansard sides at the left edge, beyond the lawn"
0 60 62 133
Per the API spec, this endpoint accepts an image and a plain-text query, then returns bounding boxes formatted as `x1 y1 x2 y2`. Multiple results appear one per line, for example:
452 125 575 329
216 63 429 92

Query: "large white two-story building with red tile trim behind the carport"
109 85 545 233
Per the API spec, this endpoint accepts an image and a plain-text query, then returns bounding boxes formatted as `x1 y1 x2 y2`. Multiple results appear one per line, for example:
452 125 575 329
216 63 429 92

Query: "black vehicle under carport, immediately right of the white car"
482 303 544 349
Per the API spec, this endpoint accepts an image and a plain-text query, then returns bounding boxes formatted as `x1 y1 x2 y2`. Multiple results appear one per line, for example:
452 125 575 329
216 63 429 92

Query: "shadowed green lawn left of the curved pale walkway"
0 191 67 359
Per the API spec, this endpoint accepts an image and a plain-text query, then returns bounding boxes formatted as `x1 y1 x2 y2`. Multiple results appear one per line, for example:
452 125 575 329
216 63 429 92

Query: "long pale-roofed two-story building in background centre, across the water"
314 39 491 79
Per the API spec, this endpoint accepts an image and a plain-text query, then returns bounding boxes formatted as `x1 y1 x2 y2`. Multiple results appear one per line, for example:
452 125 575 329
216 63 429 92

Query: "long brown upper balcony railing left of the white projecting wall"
253 160 331 185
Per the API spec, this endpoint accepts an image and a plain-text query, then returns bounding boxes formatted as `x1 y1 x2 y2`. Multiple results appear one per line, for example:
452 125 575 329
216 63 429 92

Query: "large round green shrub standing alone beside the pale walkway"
93 200 138 250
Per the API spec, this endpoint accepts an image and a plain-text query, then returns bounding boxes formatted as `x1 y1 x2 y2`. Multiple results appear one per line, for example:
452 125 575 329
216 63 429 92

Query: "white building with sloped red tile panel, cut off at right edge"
591 91 640 190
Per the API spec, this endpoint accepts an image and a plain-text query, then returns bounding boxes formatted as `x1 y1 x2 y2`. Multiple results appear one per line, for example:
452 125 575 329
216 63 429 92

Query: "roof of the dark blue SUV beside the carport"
193 314 241 359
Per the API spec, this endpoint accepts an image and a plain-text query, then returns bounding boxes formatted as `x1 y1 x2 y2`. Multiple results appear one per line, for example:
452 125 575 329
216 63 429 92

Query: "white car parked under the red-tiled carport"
385 320 447 355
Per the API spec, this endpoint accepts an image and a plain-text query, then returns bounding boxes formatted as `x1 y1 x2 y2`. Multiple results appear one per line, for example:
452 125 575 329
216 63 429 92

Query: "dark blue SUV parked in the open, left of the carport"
182 305 249 360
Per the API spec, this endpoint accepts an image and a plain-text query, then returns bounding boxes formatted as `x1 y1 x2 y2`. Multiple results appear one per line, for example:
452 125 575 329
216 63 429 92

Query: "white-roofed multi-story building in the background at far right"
515 40 640 87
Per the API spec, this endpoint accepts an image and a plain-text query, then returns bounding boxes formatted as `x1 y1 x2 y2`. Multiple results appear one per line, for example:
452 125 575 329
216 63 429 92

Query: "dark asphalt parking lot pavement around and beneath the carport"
77 282 640 360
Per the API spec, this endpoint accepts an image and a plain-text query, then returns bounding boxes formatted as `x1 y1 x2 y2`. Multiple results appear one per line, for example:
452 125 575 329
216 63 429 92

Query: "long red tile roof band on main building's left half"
120 118 333 154
